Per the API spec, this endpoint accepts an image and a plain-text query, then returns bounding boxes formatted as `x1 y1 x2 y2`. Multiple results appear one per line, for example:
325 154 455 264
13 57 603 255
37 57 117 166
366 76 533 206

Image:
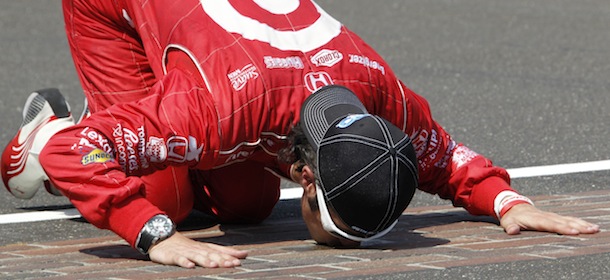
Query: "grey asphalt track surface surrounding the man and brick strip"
0 0 610 279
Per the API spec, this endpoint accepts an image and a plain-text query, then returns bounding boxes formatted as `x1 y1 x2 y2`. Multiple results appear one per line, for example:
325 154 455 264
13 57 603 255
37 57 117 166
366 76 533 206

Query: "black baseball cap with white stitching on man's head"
301 85 418 241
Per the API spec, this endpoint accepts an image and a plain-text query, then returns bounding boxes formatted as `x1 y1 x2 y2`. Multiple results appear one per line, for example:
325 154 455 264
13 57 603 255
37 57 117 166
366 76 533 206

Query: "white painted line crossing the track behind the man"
0 160 610 224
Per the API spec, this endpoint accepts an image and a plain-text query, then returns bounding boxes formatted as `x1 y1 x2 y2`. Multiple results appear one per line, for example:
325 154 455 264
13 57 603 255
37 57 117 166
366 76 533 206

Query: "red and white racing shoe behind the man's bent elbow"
0 88 74 199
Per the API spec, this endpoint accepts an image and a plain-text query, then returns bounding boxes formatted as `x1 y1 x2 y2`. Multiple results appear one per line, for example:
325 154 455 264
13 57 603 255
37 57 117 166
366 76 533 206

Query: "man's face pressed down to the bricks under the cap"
301 190 360 248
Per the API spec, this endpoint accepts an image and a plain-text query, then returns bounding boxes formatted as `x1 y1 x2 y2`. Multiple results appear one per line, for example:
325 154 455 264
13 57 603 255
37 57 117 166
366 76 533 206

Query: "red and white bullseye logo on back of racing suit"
200 0 341 52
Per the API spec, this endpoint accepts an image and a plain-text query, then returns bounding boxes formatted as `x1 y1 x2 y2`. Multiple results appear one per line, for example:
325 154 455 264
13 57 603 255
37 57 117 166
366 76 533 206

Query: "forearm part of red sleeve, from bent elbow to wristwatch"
40 126 161 245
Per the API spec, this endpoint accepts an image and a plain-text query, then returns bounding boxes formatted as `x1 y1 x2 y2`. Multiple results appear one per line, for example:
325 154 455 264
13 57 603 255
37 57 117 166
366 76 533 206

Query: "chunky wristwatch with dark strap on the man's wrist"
136 215 176 255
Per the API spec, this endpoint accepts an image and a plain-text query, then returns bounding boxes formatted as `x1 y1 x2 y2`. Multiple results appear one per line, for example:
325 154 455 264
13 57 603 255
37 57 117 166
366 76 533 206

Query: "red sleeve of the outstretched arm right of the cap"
394 83 512 217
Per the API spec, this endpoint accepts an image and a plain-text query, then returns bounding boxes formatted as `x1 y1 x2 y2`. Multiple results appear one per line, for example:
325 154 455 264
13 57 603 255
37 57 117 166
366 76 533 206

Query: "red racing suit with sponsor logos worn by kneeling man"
45 0 511 245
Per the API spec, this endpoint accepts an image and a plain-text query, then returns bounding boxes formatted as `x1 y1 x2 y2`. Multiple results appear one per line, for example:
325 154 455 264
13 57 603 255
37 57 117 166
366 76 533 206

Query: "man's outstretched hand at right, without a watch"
500 203 599 235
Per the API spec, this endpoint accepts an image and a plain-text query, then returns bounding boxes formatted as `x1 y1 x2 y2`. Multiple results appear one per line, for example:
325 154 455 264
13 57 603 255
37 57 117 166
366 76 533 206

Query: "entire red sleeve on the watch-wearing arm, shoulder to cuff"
40 70 219 245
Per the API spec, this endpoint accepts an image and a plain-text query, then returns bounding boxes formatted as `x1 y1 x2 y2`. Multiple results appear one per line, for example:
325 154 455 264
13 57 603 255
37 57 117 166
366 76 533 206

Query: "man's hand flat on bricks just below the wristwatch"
149 232 248 268
